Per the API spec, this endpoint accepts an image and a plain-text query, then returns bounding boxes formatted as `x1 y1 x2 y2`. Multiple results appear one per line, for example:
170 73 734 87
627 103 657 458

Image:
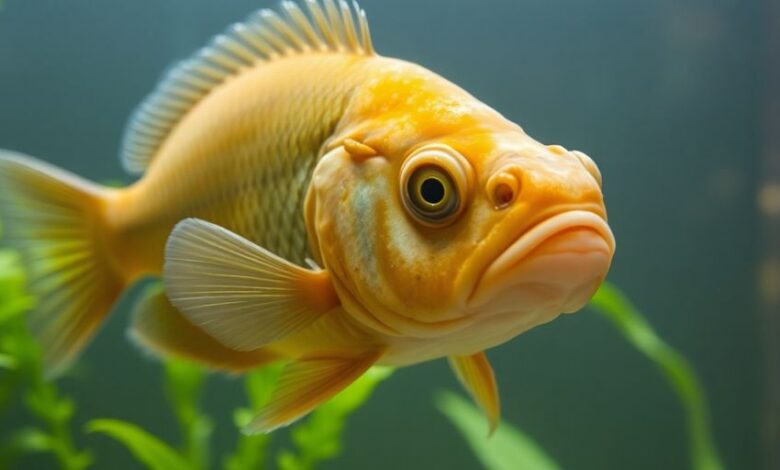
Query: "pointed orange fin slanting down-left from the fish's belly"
245 352 381 433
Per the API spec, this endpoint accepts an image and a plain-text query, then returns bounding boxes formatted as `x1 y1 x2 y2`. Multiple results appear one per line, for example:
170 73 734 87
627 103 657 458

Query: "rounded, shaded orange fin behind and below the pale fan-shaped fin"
129 285 278 372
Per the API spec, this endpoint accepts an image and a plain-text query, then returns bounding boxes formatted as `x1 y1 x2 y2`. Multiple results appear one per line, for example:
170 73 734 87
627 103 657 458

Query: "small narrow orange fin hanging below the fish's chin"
449 352 501 434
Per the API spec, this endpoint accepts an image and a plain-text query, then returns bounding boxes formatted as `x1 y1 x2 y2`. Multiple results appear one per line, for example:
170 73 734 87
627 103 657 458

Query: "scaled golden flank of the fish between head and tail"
109 54 372 276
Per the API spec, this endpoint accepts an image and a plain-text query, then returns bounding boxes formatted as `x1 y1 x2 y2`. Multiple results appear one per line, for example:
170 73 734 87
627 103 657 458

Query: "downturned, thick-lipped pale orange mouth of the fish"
468 210 615 316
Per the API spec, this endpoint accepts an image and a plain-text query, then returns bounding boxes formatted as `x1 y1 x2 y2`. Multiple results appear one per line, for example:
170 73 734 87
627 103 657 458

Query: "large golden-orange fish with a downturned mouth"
0 0 615 432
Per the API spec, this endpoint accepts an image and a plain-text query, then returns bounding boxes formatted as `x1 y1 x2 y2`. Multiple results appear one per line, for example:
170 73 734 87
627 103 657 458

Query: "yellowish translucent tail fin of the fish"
0 150 124 376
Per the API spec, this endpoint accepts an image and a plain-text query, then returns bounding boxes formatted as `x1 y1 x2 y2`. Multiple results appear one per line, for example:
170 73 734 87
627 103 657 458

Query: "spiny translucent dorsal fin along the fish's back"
120 0 374 174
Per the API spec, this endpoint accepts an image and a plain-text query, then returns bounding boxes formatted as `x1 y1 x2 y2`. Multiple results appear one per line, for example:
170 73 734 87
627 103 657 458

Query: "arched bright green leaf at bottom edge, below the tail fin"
87 419 191 470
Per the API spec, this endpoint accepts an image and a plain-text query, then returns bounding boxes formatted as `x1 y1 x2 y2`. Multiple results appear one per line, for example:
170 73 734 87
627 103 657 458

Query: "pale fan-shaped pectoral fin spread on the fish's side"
164 219 339 351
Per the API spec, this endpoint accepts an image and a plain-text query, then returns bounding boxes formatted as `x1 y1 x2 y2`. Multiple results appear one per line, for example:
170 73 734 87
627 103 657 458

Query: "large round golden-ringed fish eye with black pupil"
401 145 470 227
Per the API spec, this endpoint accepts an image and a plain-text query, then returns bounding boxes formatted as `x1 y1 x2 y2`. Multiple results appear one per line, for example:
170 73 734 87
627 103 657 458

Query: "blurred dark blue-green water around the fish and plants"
0 0 780 470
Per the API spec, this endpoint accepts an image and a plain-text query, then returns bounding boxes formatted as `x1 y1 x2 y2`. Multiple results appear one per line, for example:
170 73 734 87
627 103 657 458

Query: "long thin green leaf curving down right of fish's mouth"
590 282 724 470
